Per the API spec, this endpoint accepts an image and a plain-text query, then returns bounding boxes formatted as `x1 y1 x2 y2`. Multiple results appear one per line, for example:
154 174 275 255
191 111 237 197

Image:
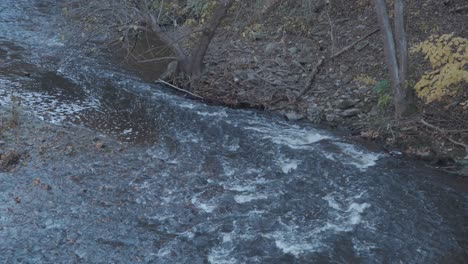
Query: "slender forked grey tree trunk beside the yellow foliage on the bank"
374 0 411 118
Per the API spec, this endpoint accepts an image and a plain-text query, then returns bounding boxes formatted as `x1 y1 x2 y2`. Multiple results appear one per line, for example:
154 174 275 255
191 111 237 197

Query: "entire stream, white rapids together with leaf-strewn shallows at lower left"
0 0 468 264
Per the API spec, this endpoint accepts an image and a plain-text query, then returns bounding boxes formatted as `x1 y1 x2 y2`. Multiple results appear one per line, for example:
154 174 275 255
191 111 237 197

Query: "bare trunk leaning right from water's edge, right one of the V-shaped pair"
190 0 235 76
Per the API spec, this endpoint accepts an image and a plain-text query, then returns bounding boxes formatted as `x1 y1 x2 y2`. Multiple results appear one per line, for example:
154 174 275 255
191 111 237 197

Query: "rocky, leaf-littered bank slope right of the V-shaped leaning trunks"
163 1 468 175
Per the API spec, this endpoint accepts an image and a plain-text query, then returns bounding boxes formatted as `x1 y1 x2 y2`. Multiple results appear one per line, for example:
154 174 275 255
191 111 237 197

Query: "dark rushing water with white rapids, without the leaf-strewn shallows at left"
0 0 468 263
